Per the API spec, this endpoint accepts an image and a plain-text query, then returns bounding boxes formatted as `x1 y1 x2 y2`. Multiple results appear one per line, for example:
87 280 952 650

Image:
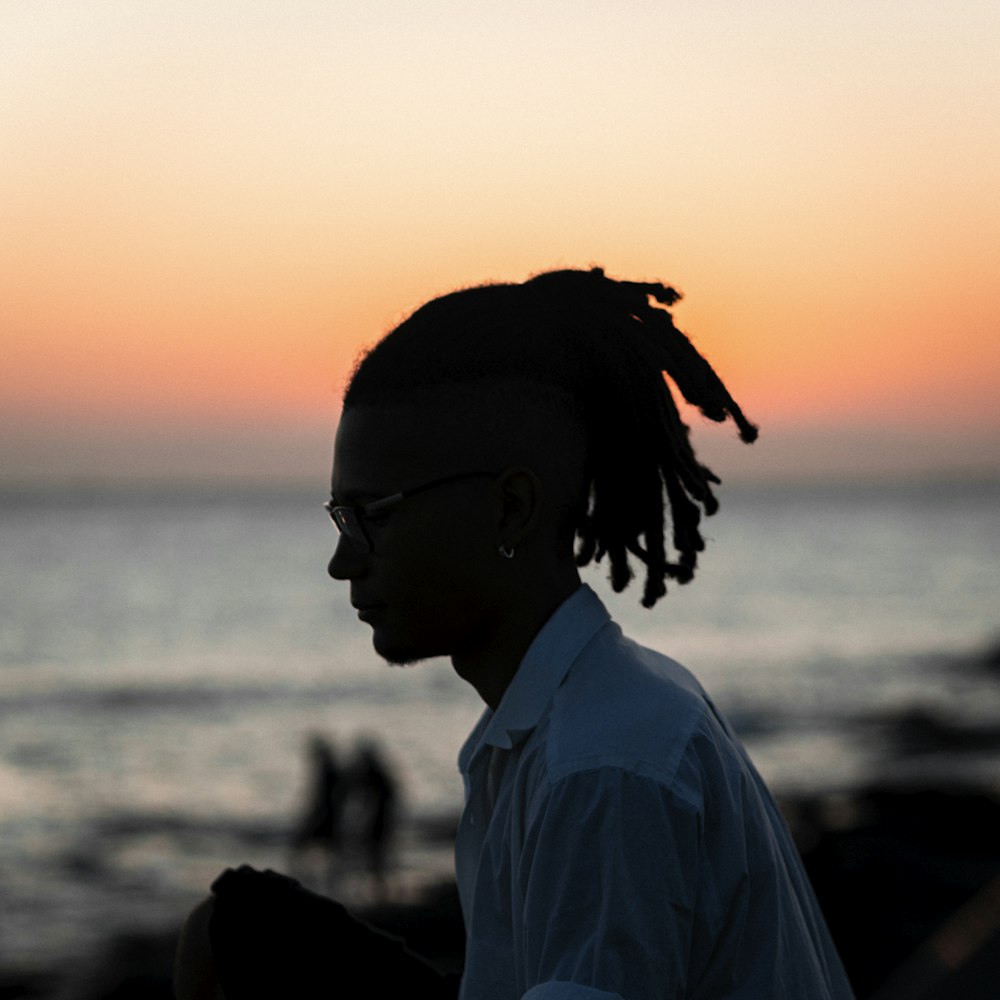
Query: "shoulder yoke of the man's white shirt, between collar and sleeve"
546 623 714 786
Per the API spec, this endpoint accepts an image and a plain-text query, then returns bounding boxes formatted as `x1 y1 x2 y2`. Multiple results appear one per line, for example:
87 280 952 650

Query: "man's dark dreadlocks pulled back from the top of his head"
344 268 757 608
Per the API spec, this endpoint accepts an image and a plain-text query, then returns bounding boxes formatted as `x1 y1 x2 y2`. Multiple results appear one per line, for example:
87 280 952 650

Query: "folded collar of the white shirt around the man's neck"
459 584 611 771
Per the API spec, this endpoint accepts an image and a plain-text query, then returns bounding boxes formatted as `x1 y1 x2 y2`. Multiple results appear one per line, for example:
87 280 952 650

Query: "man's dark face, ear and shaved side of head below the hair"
330 384 585 662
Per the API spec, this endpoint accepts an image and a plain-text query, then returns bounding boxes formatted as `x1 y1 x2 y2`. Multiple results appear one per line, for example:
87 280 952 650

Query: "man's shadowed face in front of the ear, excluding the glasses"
329 407 500 663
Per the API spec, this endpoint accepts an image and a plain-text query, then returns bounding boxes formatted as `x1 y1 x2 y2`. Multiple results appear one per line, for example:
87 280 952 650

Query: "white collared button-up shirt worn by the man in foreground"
455 586 852 1000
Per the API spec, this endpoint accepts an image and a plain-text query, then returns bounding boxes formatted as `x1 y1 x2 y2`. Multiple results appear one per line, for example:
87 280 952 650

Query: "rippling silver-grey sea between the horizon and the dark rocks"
0 482 1000 968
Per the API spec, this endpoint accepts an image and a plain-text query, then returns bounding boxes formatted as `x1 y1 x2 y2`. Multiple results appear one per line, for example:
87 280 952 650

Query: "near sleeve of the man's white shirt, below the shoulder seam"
513 767 700 1000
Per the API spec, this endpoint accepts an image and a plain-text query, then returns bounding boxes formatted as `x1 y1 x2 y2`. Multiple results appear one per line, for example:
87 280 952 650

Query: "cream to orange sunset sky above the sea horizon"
0 0 1000 483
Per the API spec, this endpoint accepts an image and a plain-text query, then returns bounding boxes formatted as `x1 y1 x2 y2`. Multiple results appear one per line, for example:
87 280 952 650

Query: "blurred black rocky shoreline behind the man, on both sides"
7 688 1000 1000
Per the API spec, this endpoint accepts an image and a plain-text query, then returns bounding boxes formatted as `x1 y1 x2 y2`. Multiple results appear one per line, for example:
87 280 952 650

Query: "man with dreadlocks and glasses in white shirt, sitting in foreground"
178 269 851 1000
